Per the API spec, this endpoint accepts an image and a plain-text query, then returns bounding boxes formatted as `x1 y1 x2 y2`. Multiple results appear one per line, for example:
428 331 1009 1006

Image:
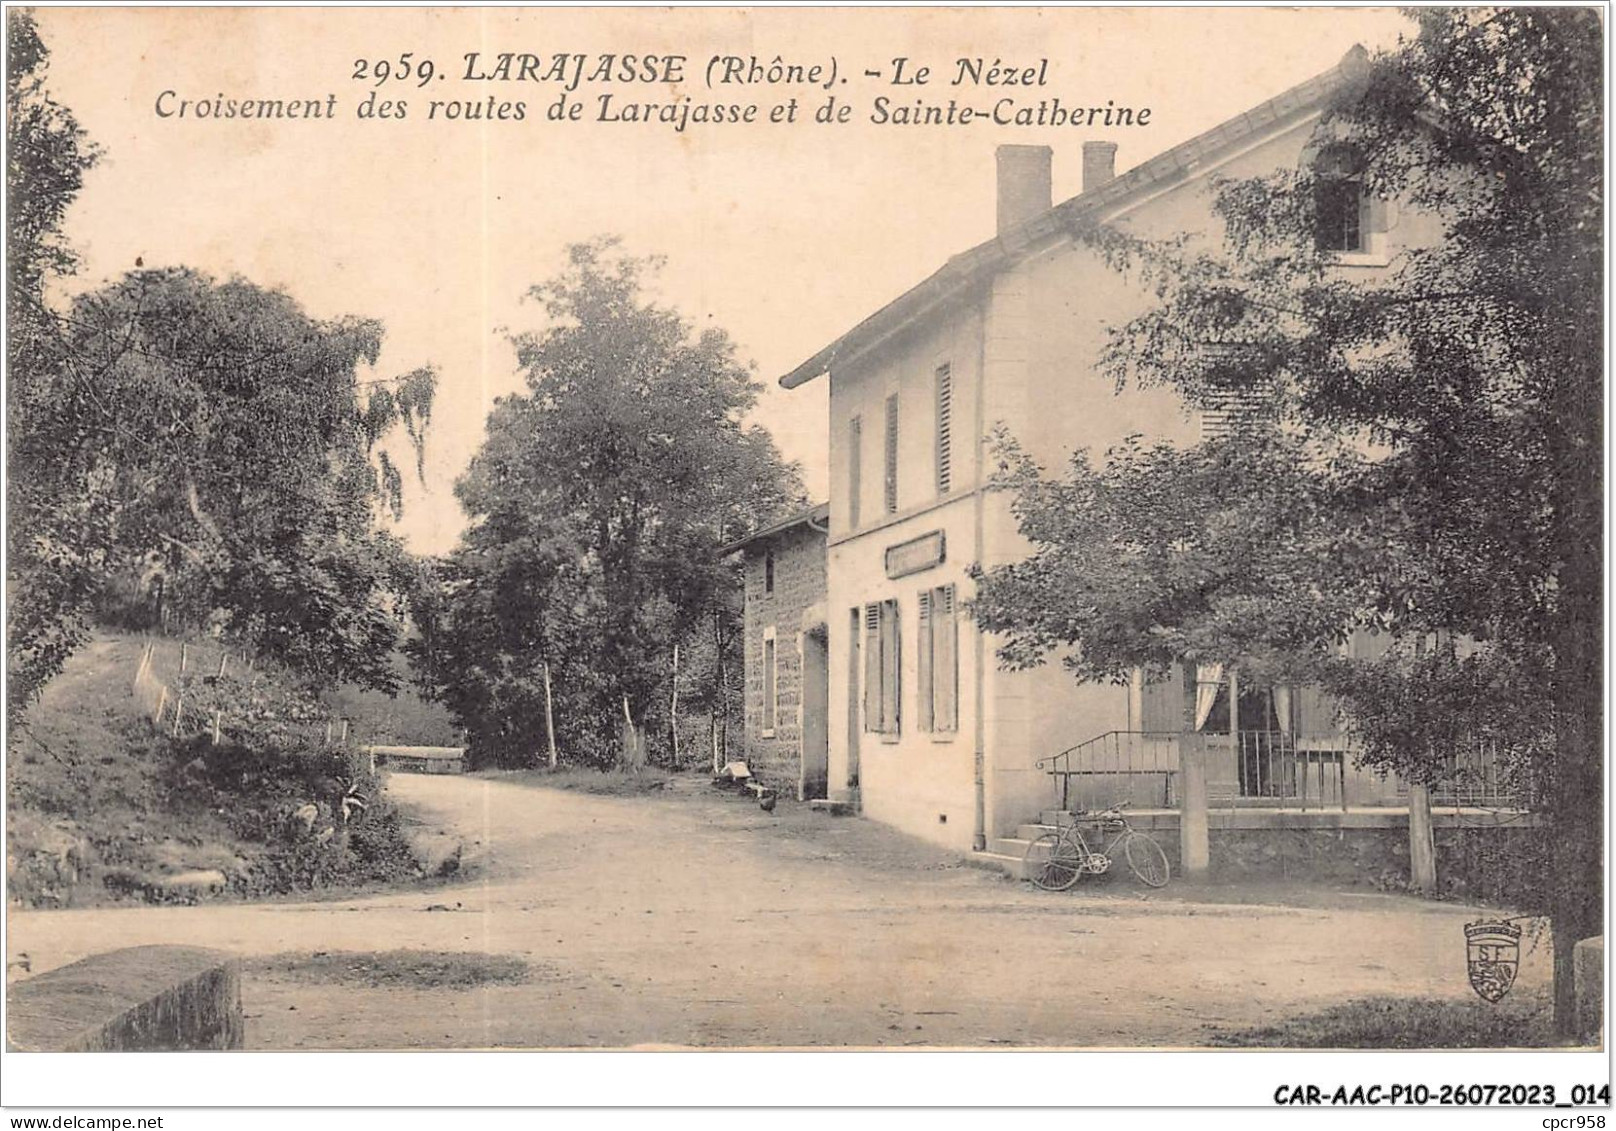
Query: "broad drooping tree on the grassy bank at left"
10 268 436 704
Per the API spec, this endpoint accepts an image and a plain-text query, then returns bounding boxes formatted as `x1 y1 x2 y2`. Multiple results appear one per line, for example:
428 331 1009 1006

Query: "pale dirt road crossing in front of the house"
6 776 1548 1049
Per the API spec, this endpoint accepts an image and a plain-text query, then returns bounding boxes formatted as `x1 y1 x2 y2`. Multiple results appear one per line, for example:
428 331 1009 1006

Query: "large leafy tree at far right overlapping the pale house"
981 8 1603 1031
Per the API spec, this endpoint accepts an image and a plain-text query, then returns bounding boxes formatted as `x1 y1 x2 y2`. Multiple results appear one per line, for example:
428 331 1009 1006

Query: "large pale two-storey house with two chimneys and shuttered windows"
775 53 1460 850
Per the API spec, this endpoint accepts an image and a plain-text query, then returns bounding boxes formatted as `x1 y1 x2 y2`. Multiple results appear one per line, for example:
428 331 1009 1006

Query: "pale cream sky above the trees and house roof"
37 8 1406 553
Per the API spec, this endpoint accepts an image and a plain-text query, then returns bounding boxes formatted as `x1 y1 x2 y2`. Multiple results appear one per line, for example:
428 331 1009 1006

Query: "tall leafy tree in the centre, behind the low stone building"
417 241 800 764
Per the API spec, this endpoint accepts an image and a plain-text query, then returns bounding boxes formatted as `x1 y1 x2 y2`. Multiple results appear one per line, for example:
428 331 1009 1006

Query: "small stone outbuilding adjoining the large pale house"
721 504 829 800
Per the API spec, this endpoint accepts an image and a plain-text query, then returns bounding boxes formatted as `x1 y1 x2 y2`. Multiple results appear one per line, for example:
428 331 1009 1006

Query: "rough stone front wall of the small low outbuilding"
745 527 826 797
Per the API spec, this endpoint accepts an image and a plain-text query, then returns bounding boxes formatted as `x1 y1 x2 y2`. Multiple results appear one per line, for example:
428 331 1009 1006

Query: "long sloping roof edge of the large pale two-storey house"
781 47 1369 389
